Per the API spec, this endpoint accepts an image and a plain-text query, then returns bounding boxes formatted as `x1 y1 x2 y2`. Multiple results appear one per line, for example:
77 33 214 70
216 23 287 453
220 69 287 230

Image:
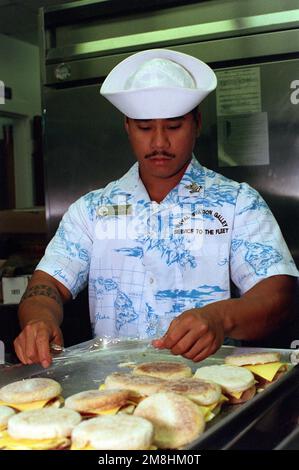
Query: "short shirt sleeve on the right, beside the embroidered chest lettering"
230 183 299 295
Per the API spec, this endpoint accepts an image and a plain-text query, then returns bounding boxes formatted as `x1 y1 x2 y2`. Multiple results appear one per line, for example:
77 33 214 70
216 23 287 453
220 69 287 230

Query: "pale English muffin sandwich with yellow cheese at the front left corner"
0 408 81 450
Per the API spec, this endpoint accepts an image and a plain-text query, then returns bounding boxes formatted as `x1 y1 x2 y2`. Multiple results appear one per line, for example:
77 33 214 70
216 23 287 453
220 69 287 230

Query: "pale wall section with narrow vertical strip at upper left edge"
0 34 41 208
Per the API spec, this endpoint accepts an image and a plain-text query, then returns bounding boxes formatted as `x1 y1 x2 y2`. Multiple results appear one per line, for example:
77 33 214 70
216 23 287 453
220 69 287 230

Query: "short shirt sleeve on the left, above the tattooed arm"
36 198 93 298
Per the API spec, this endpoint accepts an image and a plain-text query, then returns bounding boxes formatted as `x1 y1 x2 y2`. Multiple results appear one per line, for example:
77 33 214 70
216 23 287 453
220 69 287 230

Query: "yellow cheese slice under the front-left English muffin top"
0 432 70 450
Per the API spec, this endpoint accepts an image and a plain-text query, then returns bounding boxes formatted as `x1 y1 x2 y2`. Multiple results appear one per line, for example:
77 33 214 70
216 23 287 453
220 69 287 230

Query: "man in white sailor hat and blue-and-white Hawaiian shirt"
15 49 298 367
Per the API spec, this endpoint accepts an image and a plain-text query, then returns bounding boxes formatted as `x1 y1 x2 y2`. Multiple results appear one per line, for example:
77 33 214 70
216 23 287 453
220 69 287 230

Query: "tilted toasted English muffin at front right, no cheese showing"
134 392 205 449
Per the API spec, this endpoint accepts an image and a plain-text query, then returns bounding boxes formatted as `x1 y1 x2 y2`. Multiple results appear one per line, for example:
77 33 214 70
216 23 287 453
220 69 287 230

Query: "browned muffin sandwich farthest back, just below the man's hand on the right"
132 361 192 380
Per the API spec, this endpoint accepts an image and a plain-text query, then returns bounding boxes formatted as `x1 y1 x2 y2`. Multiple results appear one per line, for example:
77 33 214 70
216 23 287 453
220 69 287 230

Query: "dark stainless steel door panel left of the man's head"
44 85 135 235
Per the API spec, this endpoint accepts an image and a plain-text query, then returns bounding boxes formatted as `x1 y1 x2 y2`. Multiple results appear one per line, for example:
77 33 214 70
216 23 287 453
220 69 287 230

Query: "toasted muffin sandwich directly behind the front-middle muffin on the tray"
65 389 138 418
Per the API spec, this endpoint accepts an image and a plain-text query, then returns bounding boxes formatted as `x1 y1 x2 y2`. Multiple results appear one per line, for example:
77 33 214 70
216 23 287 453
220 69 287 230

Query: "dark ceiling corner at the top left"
0 0 80 44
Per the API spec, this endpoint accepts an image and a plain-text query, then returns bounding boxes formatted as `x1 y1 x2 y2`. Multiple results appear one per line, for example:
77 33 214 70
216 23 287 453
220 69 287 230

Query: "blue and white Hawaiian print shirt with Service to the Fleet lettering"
37 156 298 338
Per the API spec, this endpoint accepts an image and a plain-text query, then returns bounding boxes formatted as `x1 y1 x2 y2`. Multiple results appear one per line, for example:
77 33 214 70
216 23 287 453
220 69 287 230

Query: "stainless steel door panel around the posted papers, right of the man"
195 59 299 265
